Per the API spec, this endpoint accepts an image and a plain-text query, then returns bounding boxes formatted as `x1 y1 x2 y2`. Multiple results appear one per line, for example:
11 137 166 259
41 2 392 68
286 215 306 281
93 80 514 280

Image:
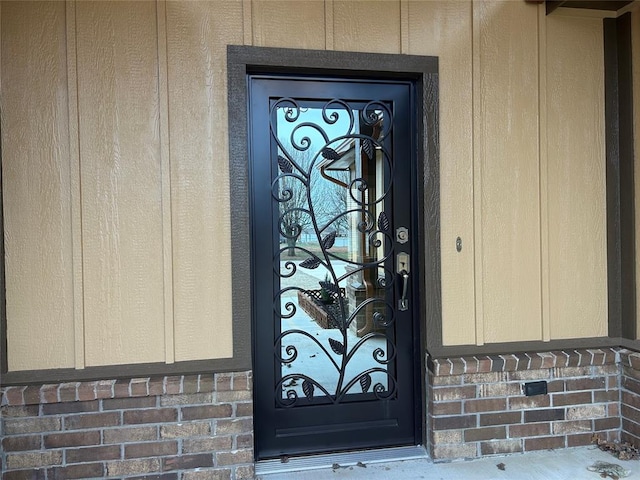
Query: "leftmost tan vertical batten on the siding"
65 1 85 369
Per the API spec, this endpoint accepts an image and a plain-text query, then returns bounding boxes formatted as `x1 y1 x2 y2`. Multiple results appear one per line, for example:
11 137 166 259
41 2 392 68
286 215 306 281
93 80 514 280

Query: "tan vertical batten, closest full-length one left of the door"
156 0 175 363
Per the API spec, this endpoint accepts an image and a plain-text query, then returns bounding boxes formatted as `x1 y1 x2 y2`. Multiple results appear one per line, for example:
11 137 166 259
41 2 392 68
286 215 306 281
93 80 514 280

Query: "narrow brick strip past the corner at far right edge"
620 350 640 446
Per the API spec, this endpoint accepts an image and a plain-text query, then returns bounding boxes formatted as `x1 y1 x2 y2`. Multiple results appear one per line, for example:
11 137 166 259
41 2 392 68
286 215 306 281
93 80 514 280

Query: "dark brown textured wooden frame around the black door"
227 45 442 456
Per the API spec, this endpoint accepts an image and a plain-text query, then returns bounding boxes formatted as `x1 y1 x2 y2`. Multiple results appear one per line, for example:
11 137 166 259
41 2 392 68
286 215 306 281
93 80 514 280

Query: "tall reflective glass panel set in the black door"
270 98 396 407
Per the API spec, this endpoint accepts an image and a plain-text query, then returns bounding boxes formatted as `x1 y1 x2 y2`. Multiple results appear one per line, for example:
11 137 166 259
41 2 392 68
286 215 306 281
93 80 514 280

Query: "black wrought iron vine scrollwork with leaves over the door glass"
270 97 397 407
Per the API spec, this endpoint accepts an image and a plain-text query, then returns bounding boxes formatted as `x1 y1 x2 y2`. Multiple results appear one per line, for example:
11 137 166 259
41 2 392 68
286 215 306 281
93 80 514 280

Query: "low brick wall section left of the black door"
0 372 254 480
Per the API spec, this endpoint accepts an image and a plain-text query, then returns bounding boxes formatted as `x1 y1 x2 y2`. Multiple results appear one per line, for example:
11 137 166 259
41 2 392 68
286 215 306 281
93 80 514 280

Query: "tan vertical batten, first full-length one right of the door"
470 0 484 345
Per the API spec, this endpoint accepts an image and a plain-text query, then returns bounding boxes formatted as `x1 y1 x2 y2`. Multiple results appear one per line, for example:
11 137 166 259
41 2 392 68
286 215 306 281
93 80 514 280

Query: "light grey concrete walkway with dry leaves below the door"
256 447 640 480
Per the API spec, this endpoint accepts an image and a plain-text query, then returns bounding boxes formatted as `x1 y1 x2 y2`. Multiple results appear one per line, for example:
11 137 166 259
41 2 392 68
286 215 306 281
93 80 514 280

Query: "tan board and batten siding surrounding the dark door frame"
0 0 608 371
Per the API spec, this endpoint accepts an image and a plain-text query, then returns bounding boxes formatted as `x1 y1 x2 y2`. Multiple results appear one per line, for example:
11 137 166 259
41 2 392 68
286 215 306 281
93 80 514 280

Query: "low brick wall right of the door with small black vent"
427 349 624 460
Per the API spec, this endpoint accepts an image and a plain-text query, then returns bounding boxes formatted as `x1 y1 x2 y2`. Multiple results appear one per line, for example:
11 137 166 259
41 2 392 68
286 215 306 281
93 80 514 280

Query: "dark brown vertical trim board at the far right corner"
603 13 636 339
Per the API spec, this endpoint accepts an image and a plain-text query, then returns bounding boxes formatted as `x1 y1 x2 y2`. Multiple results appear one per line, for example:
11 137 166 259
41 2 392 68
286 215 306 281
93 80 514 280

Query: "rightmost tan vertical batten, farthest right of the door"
538 4 551 342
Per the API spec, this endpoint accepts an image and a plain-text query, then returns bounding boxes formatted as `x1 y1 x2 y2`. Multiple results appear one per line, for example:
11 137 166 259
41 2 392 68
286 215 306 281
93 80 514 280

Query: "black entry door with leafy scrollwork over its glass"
249 75 421 459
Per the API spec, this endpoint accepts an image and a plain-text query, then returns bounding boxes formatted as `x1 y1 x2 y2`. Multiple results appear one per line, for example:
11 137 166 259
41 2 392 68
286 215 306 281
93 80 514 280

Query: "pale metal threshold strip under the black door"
255 445 428 475
